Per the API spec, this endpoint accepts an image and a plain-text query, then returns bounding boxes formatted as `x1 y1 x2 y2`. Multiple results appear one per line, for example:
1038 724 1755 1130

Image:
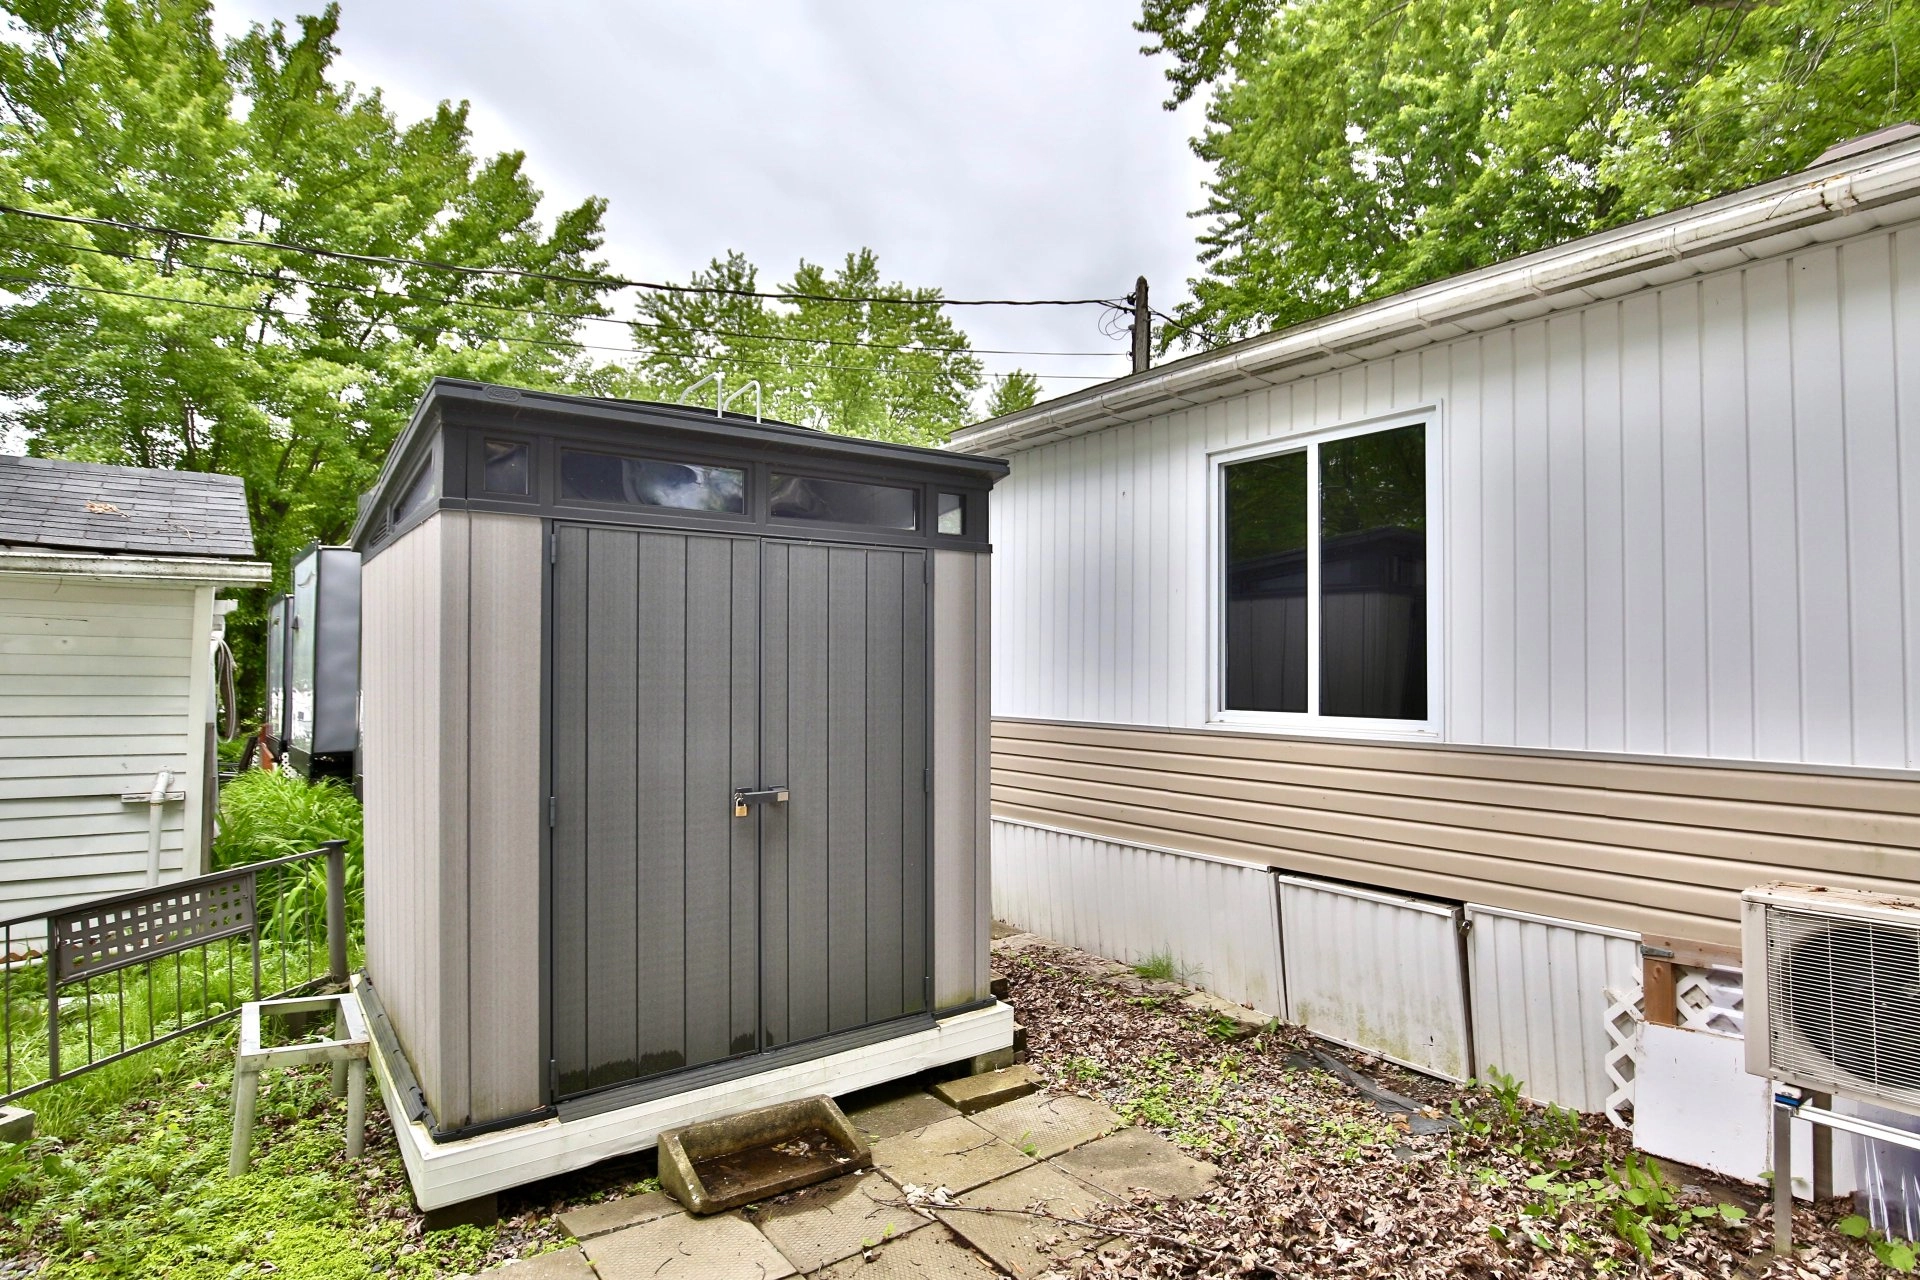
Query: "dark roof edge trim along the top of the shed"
348 378 1008 549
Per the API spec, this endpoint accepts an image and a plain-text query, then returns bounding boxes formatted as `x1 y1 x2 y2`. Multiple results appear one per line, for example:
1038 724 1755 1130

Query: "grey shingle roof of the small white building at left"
0 455 253 557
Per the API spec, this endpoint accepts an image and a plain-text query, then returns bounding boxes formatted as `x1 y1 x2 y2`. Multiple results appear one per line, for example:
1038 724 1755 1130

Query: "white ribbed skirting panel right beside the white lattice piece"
1467 906 1640 1111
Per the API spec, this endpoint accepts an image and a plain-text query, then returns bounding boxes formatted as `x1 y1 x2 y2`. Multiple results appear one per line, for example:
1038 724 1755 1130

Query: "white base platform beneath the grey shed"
355 984 1014 1209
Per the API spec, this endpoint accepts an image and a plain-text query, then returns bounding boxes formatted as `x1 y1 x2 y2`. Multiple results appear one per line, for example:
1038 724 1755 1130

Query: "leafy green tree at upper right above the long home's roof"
1137 0 1920 338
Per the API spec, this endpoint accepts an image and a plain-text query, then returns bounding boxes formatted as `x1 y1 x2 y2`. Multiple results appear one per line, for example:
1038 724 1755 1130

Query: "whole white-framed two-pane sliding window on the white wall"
1208 407 1442 737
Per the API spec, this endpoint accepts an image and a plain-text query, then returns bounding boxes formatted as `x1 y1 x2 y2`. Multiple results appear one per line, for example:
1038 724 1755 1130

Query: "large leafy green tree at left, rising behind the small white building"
0 0 605 702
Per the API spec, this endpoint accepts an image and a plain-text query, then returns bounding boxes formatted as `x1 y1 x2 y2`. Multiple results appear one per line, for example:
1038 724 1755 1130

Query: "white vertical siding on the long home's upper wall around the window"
995 228 1920 768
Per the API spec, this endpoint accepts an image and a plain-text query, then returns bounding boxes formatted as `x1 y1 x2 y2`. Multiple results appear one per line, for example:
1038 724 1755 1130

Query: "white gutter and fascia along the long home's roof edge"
947 144 1920 455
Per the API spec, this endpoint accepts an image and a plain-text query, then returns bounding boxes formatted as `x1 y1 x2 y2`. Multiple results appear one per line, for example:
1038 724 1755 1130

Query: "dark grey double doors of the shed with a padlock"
549 524 929 1098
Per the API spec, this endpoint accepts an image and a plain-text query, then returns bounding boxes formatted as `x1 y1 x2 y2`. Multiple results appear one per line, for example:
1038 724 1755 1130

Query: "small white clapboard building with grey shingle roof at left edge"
0 457 271 950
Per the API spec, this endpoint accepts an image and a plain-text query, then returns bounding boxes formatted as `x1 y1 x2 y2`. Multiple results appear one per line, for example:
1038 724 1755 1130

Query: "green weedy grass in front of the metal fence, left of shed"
0 1025 522 1280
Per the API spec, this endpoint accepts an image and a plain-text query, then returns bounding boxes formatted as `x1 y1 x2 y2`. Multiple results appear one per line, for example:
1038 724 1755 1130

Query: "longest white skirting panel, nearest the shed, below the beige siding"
993 819 1284 1015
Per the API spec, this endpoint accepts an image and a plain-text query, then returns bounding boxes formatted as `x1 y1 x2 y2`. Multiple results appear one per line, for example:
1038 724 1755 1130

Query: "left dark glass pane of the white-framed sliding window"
1225 453 1308 712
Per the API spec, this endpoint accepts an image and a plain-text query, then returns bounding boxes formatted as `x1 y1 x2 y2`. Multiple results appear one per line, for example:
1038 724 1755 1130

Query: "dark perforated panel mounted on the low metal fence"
48 869 255 983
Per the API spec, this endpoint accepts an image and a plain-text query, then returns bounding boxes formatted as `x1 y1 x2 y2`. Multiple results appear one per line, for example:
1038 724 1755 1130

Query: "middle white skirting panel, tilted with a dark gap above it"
1275 875 1473 1080
